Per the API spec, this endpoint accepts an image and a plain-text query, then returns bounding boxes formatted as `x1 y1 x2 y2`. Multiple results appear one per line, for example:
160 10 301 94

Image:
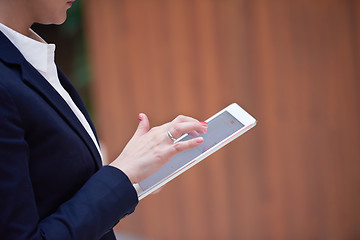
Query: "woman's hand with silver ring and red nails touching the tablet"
110 114 207 183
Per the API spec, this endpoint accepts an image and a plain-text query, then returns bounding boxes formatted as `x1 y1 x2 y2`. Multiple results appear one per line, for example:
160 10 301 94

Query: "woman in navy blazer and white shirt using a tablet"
0 0 207 240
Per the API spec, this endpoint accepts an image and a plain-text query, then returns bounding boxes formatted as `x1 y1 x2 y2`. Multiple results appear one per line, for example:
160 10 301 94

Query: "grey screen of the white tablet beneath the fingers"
139 111 244 191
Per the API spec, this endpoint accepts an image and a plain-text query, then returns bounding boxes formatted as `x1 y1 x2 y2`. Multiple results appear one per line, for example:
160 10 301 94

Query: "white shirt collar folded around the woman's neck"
0 23 55 73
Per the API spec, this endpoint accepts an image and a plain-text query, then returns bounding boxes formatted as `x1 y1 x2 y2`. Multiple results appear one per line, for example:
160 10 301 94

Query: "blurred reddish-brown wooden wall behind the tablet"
84 0 360 240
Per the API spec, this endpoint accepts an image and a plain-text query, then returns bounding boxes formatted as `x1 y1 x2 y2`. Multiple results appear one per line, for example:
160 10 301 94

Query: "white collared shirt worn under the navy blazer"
0 23 102 161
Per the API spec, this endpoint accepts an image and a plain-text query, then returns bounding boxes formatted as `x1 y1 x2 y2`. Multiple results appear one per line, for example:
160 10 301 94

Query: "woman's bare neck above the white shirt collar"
0 0 33 38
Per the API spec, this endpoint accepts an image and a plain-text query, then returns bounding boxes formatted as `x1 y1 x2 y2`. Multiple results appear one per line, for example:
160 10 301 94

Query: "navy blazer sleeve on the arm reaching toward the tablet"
0 85 138 240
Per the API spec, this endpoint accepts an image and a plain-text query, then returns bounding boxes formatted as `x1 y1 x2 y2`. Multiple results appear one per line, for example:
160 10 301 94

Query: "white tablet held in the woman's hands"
134 103 256 200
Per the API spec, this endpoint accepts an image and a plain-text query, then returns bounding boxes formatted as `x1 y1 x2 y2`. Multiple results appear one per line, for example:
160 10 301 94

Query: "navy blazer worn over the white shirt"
0 31 138 240
